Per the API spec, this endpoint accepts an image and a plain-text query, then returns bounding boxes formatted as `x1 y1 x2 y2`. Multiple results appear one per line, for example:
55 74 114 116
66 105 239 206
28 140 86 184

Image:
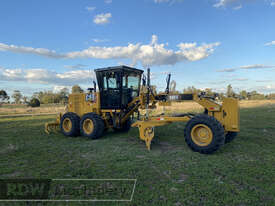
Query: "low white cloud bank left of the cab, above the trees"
0 68 95 86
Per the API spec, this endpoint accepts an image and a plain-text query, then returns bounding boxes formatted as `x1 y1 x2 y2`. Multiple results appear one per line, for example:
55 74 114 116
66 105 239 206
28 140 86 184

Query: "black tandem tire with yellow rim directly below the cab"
80 113 105 139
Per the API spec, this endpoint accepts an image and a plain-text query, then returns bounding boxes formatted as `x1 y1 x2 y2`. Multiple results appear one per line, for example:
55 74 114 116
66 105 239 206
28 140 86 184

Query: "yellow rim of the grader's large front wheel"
191 124 213 146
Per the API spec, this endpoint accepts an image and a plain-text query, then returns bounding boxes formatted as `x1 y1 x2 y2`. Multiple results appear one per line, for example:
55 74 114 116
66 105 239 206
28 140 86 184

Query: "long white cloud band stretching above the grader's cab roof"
0 35 220 66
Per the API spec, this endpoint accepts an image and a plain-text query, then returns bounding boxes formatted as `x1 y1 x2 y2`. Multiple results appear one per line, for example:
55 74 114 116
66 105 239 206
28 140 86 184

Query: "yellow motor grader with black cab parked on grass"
45 66 240 154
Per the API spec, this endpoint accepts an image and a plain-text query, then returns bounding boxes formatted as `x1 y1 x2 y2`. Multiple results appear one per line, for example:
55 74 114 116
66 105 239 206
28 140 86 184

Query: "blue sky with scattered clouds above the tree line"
0 0 275 95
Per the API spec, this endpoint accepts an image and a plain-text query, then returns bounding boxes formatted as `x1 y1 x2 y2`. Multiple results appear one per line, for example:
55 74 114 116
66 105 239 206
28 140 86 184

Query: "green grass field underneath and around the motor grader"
0 106 275 206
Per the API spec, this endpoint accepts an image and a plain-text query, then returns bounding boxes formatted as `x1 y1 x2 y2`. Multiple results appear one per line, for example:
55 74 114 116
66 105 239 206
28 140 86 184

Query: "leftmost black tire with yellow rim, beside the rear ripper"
60 112 80 137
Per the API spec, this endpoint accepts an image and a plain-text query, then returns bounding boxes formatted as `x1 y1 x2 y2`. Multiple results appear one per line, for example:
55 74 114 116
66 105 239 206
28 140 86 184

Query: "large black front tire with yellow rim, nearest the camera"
184 114 225 154
